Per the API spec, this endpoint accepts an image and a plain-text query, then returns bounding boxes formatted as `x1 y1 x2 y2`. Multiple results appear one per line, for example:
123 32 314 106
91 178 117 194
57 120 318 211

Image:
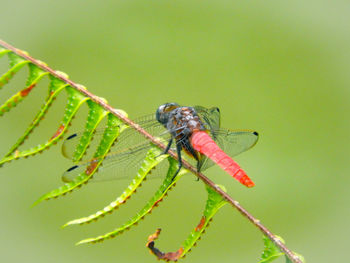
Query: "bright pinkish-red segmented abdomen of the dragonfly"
191 131 254 187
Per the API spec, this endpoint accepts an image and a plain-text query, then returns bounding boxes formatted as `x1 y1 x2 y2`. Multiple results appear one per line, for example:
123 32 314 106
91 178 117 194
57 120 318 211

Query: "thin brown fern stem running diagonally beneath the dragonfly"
0 39 302 263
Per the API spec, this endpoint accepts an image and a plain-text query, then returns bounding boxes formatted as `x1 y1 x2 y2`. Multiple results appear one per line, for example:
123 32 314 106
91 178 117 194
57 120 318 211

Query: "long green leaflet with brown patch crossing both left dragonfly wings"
33 114 126 205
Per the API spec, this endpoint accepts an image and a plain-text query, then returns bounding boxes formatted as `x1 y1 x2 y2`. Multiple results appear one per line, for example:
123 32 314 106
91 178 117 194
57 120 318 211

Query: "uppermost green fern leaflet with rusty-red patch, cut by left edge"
0 64 49 117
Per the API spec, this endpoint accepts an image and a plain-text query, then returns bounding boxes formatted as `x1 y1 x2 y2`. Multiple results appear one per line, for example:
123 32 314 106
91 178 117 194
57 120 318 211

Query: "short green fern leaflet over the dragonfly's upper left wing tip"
67 101 108 162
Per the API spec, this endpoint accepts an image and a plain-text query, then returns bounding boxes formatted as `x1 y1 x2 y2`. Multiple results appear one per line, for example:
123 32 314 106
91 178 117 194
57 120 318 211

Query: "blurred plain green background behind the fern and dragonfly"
0 0 350 263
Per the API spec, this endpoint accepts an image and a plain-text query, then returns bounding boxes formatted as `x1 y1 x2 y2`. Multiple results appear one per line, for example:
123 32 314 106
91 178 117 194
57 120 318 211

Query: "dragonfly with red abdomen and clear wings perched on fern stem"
62 103 259 187
